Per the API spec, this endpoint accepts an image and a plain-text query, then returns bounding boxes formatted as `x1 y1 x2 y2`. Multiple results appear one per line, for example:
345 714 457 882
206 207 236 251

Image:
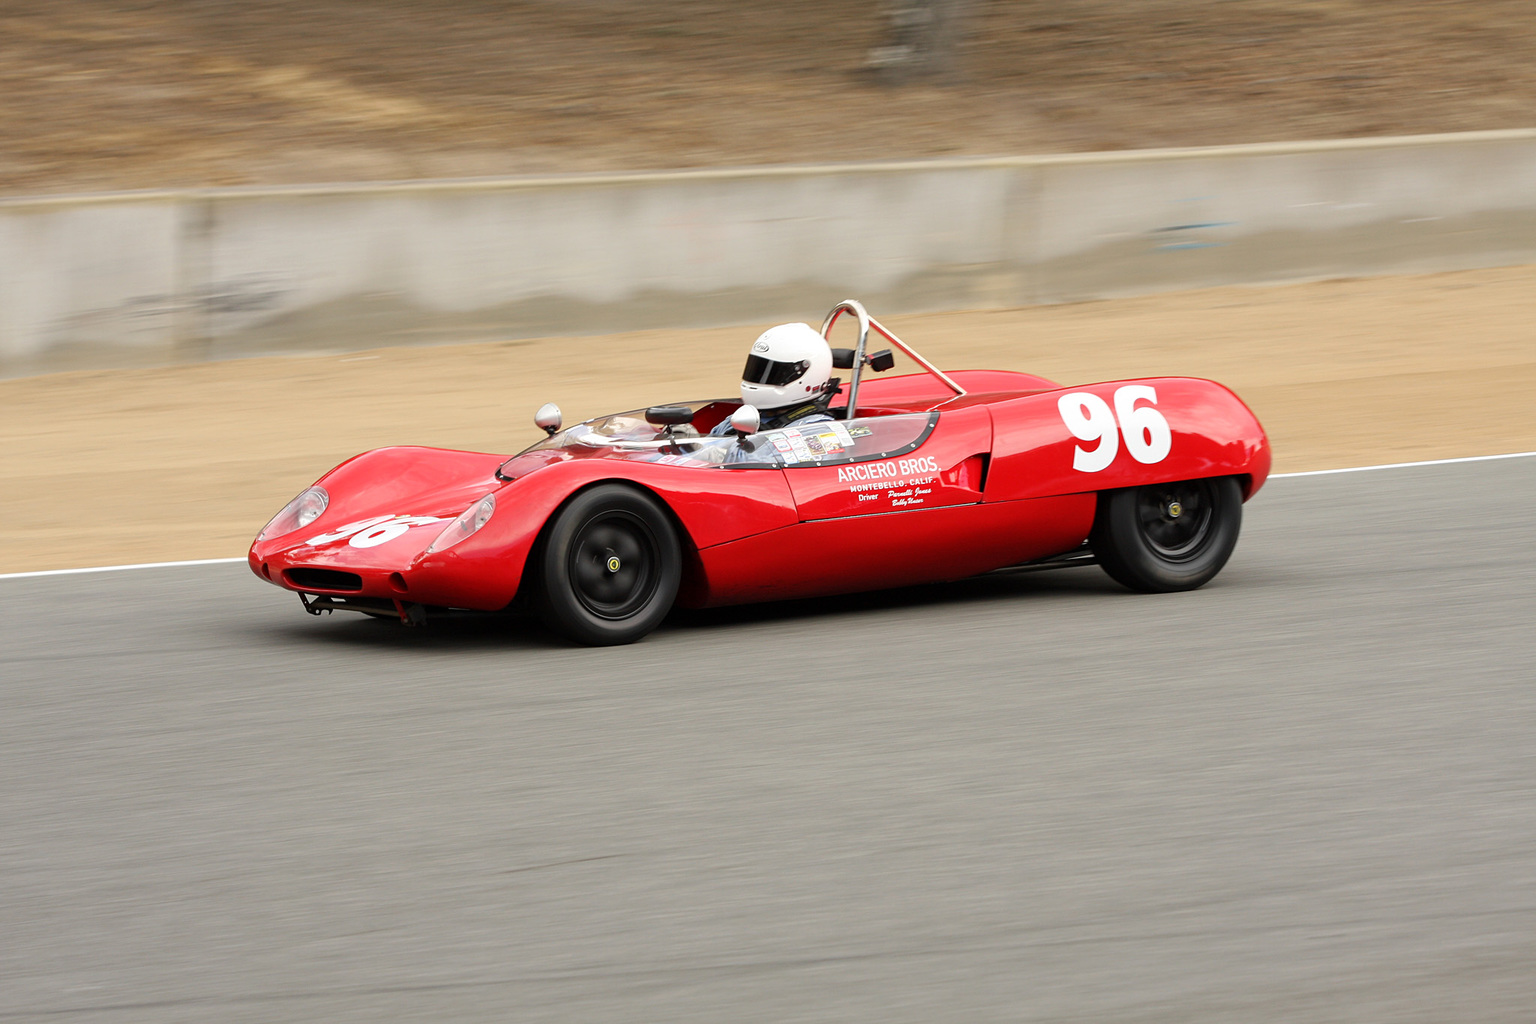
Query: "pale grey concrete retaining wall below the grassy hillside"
0 130 1536 375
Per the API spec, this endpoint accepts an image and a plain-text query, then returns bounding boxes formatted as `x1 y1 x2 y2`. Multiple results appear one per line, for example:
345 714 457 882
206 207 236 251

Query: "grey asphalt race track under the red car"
0 459 1536 1024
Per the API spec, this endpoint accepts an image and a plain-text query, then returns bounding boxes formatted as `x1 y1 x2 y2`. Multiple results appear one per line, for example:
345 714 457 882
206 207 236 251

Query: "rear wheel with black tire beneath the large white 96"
1089 476 1243 594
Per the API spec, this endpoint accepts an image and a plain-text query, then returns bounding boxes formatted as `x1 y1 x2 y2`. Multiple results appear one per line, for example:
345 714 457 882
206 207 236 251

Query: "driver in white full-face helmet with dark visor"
710 324 840 434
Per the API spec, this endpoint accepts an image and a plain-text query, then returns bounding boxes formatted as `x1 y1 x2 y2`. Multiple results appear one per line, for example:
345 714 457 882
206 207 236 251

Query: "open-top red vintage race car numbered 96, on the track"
249 301 1270 643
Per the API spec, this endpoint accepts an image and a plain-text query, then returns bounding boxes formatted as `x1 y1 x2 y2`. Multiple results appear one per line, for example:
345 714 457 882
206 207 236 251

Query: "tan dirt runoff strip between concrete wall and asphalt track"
0 267 1536 573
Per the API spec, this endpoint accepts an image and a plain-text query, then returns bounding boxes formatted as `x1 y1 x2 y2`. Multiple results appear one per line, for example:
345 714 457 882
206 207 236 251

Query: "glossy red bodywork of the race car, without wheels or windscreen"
249 370 1269 609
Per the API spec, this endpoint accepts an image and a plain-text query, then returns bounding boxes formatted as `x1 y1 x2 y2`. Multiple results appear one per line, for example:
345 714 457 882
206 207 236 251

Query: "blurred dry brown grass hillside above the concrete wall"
0 0 1536 195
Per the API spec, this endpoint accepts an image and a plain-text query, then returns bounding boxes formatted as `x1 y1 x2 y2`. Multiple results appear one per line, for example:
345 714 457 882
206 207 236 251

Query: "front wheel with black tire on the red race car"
533 484 682 646
